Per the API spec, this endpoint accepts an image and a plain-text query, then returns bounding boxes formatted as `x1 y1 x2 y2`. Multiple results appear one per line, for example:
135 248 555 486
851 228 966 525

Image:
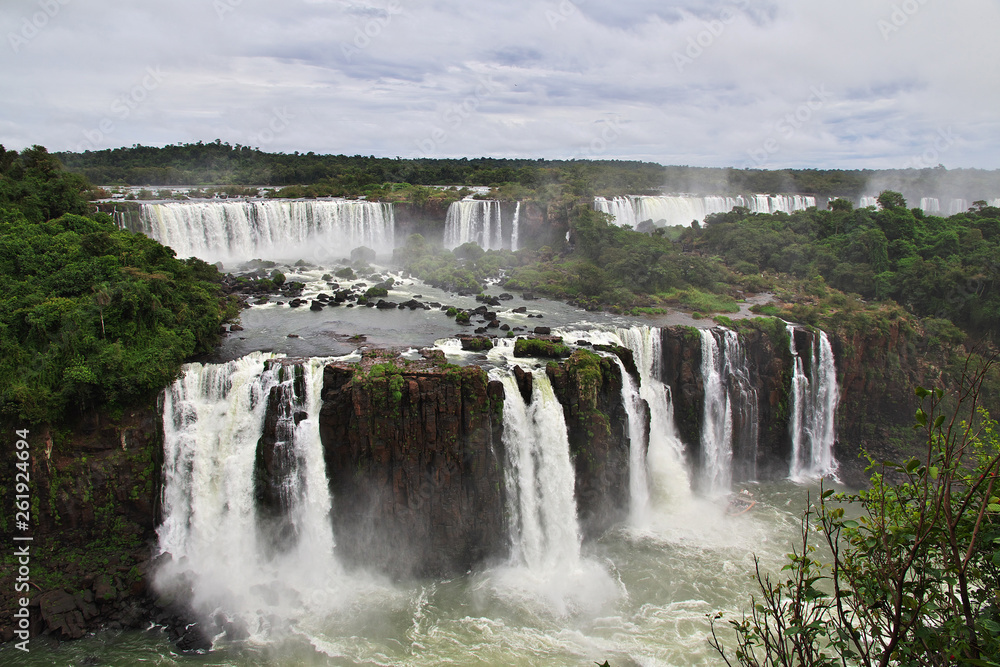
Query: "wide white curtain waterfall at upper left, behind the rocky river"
132 200 395 263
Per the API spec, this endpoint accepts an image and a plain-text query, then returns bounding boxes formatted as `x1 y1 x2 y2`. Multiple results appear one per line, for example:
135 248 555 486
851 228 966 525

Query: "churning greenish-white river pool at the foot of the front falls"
11 483 805 667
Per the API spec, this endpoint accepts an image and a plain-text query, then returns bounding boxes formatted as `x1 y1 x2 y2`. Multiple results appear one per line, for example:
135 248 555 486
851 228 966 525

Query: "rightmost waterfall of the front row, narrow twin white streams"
787 324 840 480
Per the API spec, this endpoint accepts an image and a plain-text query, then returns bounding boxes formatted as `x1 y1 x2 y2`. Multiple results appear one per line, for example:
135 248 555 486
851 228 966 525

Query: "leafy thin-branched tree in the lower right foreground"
711 363 1000 667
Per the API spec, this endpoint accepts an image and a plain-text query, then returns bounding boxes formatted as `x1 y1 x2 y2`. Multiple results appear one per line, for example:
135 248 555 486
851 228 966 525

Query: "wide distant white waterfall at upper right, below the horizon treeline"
594 195 816 228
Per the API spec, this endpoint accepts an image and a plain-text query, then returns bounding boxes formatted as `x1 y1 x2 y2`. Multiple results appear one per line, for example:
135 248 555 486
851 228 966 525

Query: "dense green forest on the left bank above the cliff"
0 146 238 424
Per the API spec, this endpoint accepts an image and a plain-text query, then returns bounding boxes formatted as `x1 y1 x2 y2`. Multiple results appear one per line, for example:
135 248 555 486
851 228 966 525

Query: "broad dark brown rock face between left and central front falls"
320 351 509 577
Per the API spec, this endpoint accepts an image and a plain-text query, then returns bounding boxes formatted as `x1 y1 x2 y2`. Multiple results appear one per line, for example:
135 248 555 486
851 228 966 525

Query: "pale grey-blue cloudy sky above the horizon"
0 0 1000 169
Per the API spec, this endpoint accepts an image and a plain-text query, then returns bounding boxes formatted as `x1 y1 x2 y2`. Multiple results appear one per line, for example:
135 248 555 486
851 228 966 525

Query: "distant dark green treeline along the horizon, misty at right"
55 139 1000 200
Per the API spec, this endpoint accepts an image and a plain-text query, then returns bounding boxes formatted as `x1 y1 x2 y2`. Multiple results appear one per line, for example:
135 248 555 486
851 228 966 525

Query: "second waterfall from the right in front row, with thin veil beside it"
700 328 759 493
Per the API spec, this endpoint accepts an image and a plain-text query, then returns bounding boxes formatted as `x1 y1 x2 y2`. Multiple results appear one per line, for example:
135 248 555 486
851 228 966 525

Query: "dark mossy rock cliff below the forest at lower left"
0 407 162 641
